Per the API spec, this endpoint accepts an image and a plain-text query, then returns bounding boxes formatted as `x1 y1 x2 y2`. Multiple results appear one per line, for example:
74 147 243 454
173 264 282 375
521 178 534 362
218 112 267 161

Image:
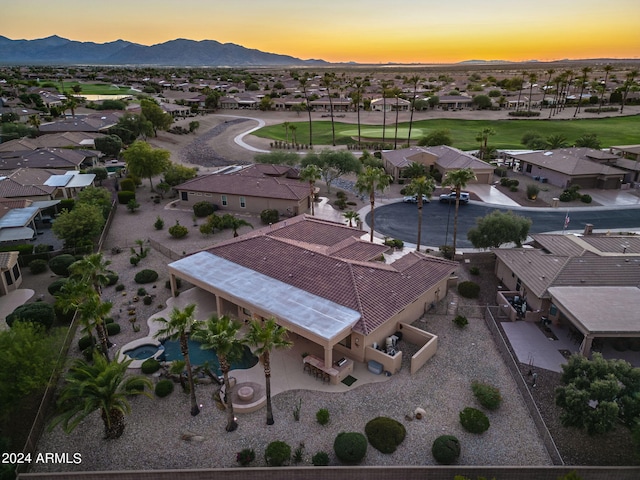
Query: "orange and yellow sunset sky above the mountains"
5 0 640 63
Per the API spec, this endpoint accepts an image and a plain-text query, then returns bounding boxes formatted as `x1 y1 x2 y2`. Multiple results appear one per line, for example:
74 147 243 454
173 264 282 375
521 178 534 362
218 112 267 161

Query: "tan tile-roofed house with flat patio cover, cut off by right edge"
494 234 640 355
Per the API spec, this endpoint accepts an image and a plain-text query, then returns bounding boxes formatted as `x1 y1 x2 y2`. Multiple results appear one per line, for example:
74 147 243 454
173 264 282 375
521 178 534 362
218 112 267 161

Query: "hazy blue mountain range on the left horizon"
0 35 328 67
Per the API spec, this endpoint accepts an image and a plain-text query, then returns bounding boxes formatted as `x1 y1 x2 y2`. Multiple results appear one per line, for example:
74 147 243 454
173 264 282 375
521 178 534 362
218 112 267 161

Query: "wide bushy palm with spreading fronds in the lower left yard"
50 353 152 439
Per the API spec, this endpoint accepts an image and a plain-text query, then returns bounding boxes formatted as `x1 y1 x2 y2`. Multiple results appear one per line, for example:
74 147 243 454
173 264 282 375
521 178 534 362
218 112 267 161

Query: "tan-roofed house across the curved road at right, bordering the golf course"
507 148 627 190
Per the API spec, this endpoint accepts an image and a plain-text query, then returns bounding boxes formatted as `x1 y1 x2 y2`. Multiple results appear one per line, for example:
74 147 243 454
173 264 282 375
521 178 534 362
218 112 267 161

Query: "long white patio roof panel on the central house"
169 252 360 340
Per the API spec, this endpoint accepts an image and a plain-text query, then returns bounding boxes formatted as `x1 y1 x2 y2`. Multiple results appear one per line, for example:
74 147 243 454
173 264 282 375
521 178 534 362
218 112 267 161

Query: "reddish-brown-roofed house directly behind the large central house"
175 164 312 216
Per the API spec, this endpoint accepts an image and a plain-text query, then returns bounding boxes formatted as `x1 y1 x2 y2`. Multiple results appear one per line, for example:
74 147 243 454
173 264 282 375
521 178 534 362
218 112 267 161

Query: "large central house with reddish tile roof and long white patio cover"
168 215 457 383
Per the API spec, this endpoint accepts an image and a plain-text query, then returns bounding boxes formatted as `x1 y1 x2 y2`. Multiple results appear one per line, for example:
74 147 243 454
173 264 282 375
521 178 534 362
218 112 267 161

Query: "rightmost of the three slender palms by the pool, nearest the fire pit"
245 318 293 425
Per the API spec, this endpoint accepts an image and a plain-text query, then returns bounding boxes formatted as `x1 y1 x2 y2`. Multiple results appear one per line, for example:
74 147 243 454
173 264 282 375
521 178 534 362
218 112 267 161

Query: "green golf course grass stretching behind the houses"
254 112 639 150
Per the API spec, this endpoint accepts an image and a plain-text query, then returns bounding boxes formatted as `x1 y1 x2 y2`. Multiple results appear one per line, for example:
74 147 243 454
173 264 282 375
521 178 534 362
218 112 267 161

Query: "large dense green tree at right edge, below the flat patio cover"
556 352 640 434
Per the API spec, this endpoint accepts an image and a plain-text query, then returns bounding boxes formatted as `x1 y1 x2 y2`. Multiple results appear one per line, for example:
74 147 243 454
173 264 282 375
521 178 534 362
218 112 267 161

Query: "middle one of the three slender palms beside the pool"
193 315 244 432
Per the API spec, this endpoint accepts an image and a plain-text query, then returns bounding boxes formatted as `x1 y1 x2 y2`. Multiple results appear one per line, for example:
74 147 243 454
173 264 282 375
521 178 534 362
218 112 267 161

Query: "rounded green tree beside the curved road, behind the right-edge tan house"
467 210 531 248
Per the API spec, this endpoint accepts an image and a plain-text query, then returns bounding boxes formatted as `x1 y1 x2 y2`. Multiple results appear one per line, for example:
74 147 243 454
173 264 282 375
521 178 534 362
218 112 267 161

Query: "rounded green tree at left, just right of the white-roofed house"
51 203 105 248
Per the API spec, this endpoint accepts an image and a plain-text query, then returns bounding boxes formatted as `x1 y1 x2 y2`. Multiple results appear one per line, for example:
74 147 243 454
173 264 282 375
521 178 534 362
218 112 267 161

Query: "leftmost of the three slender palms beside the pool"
154 303 200 417
